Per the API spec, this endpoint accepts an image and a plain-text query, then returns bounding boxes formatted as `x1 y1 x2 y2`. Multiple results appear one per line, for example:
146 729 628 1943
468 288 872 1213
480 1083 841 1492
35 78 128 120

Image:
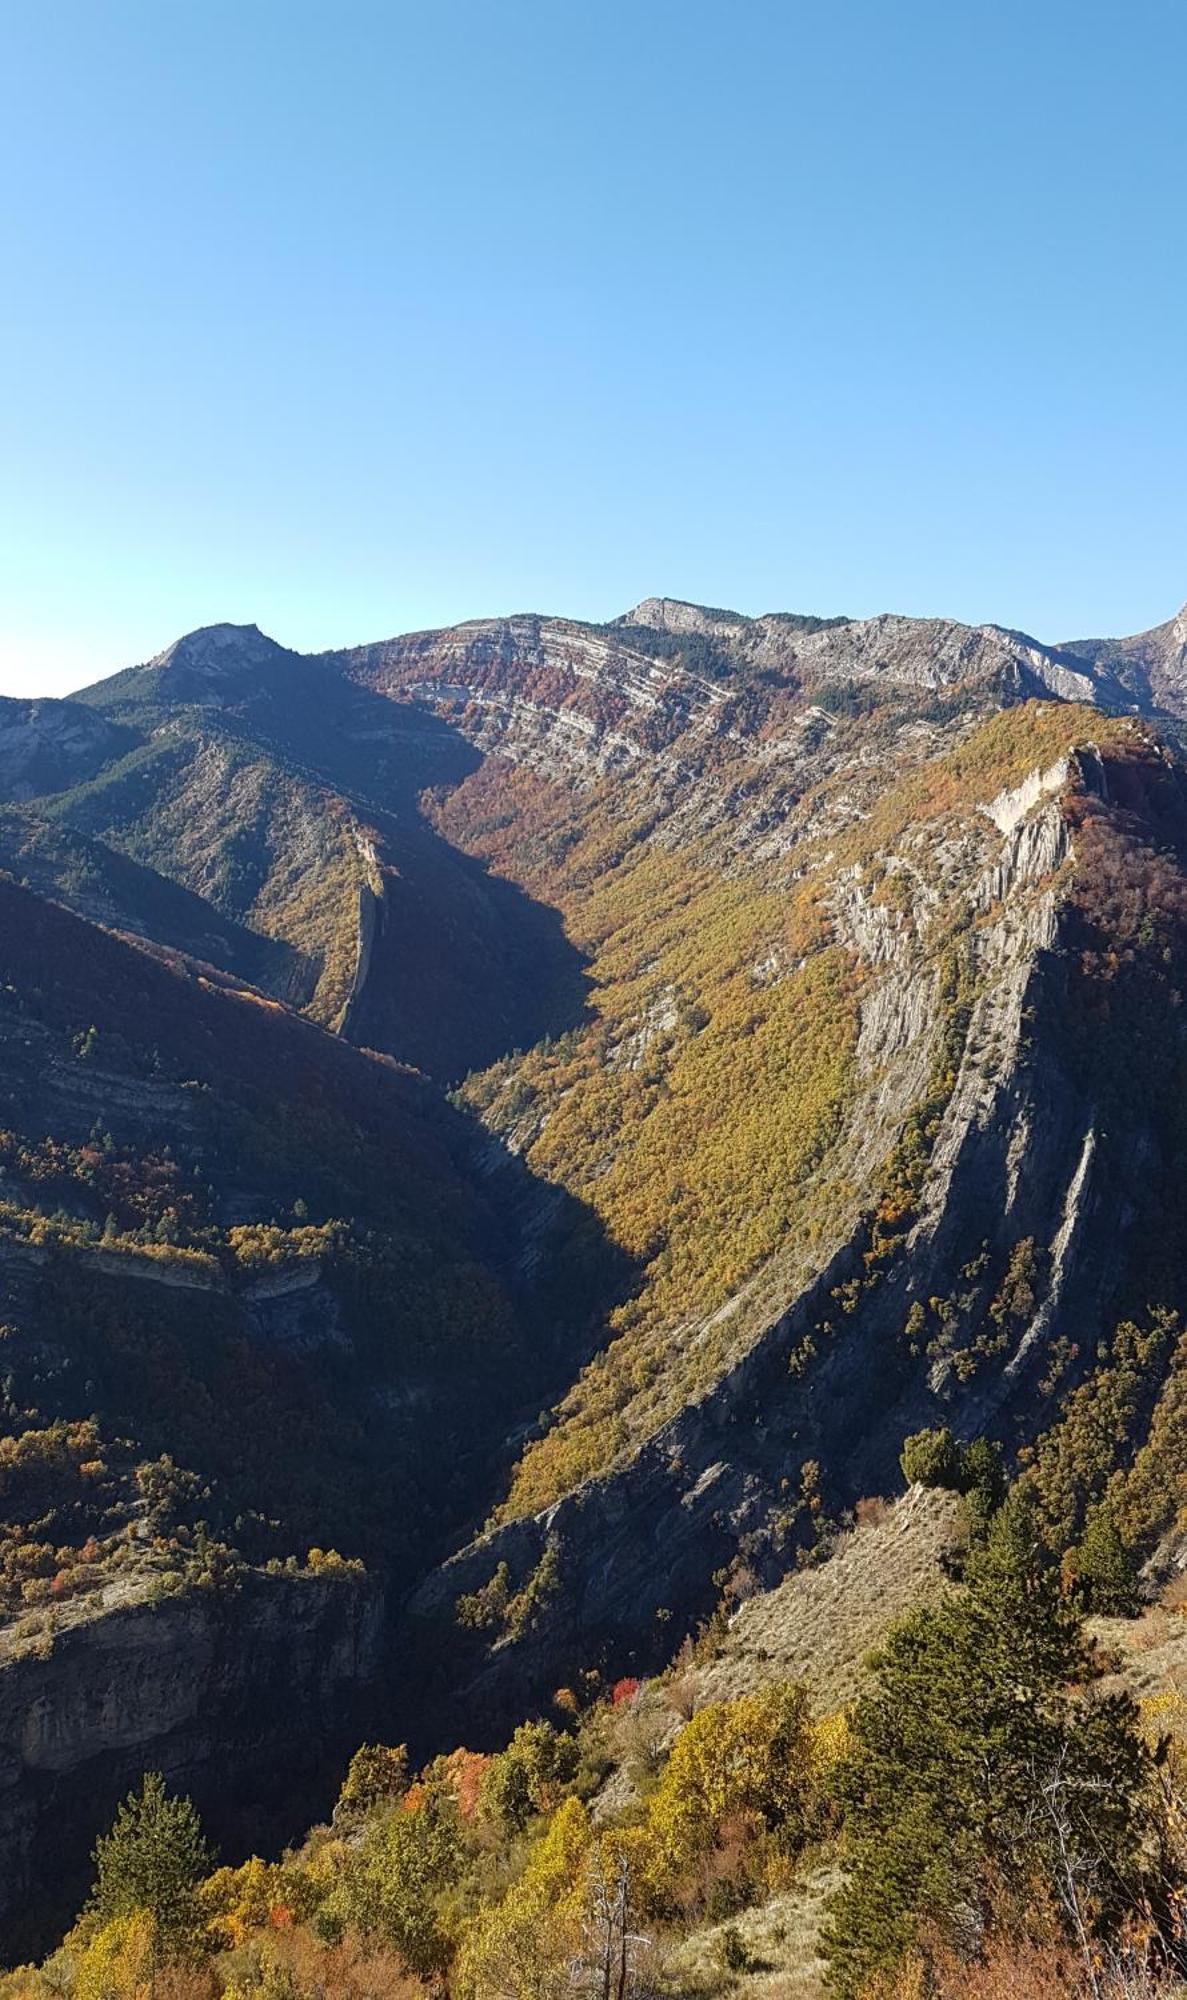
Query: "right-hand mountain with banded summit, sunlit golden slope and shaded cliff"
325 600 1181 1736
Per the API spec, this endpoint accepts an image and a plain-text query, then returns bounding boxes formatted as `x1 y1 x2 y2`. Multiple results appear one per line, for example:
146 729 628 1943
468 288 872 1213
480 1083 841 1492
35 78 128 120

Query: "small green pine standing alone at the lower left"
90 1770 210 1958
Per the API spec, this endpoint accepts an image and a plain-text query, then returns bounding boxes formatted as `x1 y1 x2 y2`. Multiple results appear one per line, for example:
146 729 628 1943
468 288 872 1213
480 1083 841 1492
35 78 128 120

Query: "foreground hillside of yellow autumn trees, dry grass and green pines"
11 1488 1187 2000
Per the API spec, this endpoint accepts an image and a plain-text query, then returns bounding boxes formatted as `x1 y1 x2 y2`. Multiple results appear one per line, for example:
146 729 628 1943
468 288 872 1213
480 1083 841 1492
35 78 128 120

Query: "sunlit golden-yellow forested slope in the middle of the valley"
444 704 1127 1512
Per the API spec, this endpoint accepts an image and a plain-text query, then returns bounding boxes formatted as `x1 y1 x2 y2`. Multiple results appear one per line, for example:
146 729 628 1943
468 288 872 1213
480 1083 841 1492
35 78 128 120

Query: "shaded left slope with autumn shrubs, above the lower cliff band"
0 878 587 1612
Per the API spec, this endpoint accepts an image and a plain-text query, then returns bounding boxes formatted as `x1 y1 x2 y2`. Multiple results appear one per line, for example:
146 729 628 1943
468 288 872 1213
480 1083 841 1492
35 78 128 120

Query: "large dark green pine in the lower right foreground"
825 1490 1149 2000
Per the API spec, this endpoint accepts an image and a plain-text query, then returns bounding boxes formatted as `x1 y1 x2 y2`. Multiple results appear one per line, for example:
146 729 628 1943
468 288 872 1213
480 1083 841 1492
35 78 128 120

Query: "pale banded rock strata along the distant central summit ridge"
334 598 1129 780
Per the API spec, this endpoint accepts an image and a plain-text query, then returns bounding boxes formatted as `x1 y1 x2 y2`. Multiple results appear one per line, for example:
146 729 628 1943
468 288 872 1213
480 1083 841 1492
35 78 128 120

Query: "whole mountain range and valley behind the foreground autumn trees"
0 598 1187 1944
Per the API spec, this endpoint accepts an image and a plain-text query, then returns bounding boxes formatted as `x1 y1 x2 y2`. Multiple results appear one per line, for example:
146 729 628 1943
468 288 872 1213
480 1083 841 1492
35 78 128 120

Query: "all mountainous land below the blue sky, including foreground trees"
0 598 1187 2000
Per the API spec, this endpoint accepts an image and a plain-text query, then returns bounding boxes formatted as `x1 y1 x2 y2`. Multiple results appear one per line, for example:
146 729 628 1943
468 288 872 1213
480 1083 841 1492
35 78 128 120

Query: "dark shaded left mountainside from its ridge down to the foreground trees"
0 876 599 1942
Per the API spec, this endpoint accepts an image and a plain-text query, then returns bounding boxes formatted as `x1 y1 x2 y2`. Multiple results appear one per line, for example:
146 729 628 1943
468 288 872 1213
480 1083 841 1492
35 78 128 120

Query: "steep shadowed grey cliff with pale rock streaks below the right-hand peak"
408 746 1157 1736
